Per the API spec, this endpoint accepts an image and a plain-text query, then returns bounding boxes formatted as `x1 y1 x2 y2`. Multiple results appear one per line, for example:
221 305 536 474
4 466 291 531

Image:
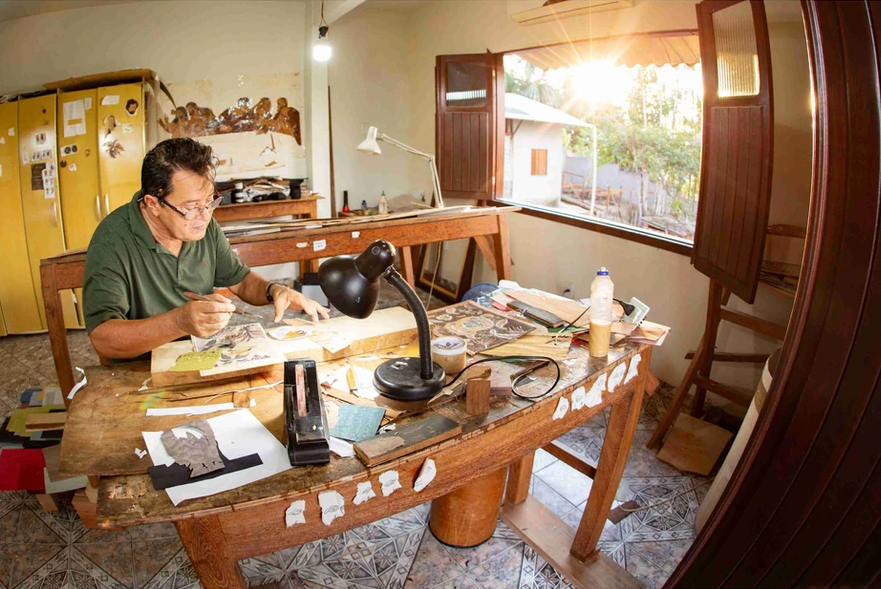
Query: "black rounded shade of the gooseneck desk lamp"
318 239 396 319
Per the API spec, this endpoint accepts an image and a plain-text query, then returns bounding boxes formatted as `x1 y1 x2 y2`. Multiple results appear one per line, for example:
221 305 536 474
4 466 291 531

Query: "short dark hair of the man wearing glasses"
141 137 216 198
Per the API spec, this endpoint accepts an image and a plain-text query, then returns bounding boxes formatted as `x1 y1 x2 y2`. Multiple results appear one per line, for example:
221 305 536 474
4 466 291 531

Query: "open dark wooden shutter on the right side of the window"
692 0 773 303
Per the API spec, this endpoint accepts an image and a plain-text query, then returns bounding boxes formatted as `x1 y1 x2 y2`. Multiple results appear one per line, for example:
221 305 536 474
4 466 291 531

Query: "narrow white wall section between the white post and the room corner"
328 2 412 209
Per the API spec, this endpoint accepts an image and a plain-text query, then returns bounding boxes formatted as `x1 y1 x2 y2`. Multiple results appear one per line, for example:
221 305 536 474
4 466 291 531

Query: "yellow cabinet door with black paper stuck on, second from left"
18 94 79 329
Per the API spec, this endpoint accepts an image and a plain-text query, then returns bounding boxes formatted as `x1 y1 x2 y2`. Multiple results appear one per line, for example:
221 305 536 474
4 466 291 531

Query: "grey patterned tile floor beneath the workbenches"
0 286 707 589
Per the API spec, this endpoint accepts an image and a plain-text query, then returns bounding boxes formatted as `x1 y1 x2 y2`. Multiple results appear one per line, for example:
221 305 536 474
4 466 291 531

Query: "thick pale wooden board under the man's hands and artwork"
150 307 417 387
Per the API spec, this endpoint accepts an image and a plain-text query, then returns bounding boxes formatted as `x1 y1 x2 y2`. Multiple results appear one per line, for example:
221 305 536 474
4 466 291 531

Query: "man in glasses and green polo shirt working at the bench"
83 138 328 358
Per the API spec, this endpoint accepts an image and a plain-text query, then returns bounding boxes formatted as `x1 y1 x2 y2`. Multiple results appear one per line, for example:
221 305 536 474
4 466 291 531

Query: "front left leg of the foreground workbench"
174 516 248 589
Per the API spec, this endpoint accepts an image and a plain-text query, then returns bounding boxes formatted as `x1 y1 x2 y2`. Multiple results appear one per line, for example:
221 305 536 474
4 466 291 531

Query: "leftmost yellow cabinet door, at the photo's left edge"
0 102 42 333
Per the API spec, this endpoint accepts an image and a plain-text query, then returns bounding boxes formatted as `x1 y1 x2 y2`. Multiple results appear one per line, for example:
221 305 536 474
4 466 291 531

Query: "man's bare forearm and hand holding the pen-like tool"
89 294 235 358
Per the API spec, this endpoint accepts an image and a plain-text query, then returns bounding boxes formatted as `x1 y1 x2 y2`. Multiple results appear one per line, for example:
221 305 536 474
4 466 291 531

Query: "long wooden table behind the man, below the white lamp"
40 207 520 397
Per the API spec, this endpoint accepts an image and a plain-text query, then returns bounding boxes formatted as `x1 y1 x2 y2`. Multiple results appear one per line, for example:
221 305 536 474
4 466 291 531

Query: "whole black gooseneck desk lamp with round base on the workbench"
318 239 445 401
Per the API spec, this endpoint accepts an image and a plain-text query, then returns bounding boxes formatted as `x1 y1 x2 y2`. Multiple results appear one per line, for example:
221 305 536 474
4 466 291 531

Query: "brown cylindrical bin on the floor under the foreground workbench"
428 468 508 548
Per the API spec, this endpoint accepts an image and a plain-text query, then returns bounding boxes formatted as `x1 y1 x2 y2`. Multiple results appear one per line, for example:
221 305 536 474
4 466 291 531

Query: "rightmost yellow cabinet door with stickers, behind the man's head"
97 84 144 216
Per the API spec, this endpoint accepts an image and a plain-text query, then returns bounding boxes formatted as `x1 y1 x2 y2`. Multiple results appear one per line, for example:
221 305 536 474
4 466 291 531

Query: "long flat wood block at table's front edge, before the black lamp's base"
355 414 462 466
